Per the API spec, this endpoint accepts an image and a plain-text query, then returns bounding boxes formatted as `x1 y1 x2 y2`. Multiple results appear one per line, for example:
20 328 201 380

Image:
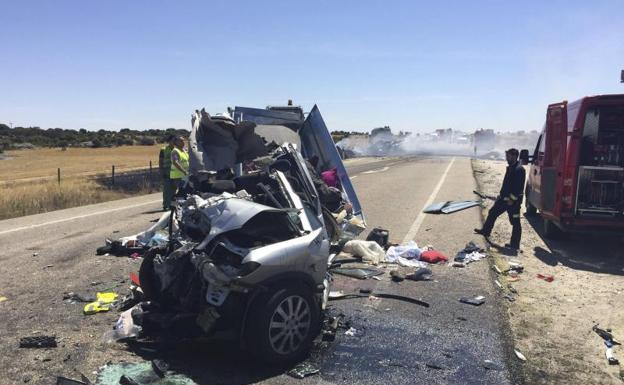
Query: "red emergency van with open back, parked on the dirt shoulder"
520 95 624 237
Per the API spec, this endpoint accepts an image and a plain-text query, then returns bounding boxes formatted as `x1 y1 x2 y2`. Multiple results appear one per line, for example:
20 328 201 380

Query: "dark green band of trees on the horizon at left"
0 123 189 151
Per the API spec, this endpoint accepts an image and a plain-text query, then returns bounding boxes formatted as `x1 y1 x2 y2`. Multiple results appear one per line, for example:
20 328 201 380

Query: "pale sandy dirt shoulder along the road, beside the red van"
473 160 624 385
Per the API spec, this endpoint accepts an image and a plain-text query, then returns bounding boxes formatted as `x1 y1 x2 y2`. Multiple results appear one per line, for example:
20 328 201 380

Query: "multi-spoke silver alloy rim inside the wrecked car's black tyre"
269 295 312 355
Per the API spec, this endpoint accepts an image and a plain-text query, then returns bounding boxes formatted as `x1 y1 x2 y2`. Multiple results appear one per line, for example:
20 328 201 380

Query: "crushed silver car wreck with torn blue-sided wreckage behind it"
117 106 365 362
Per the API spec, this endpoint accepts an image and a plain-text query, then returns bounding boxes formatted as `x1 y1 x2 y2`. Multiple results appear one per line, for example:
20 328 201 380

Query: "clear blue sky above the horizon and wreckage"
0 0 624 132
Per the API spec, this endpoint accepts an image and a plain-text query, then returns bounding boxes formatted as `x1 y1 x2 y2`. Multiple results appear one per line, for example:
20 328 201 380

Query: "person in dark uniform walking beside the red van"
474 148 526 250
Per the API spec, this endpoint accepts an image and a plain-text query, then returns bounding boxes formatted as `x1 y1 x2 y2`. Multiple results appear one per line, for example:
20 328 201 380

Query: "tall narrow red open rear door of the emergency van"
541 102 568 217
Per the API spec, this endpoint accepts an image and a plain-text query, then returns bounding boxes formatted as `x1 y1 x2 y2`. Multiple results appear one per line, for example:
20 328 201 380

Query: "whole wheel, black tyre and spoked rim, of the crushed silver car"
246 283 320 364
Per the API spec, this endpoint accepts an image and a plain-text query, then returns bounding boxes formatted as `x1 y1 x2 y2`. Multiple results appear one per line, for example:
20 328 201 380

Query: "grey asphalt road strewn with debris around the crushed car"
0 157 517 384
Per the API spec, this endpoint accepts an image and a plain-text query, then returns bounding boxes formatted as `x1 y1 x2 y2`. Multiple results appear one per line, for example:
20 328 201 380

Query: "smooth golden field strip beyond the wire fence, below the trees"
0 146 160 182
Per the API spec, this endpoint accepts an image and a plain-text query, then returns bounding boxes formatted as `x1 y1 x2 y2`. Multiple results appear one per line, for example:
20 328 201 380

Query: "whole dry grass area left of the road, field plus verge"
0 146 160 220
